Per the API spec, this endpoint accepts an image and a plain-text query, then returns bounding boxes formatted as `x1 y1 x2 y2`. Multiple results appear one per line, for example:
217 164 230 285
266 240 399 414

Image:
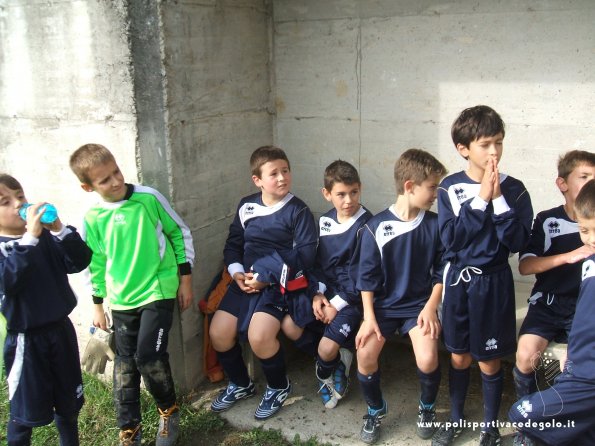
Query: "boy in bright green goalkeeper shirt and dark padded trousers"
70 144 194 446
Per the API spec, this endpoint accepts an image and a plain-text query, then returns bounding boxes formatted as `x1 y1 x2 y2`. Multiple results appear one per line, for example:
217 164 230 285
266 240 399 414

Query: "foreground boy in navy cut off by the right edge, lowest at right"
508 180 595 446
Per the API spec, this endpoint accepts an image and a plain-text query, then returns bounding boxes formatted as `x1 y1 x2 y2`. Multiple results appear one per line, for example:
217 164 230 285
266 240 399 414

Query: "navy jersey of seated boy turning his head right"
356 205 444 318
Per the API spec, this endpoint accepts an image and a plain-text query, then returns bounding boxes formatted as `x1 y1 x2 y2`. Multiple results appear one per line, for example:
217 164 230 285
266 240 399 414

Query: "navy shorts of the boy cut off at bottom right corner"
508 371 595 446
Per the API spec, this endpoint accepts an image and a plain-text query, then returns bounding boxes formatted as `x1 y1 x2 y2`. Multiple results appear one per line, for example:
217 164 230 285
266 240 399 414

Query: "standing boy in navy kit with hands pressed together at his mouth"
432 105 533 446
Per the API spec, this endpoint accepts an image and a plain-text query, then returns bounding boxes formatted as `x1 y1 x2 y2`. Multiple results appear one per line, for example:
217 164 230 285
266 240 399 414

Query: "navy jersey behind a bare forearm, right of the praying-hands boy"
519 206 583 297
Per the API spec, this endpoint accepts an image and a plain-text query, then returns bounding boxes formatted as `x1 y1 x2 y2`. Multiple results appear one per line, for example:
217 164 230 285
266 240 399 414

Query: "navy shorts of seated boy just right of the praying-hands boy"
519 296 576 343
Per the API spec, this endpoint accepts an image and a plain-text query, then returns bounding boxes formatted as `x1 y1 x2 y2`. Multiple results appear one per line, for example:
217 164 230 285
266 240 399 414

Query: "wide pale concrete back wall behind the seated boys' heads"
274 0 595 278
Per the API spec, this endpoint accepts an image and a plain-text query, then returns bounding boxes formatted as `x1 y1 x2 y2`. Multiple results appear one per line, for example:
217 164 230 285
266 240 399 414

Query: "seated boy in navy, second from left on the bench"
312 160 372 409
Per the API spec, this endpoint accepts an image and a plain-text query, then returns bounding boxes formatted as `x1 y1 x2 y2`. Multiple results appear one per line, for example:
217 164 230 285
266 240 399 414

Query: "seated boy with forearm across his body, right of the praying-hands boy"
513 150 595 446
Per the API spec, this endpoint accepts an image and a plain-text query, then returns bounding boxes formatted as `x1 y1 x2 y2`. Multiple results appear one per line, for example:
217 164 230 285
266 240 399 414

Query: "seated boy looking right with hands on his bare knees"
355 149 446 444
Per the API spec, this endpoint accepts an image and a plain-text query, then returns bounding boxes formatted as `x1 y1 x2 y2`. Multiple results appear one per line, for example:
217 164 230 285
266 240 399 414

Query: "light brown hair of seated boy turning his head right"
395 149 447 195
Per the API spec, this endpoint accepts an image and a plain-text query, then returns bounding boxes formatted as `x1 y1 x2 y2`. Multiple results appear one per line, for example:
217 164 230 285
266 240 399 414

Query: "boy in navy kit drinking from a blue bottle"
0 174 91 446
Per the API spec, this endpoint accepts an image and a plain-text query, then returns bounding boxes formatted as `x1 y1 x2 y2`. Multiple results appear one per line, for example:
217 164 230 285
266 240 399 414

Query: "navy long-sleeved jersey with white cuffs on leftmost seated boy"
223 193 317 283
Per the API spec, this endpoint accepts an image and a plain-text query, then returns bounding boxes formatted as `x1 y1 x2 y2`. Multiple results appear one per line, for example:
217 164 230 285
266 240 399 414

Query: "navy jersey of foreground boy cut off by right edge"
567 254 595 380
